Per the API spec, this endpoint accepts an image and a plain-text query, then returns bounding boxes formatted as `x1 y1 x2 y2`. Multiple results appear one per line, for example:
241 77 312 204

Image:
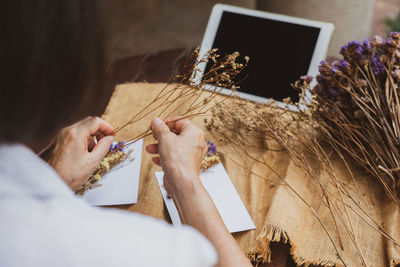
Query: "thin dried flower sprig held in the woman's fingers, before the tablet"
110 48 248 151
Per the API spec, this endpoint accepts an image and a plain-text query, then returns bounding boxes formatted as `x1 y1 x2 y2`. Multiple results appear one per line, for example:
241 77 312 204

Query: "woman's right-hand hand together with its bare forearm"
146 118 251 267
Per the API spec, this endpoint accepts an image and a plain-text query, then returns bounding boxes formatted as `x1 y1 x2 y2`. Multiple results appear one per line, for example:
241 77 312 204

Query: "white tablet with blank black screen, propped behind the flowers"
196 4 334 106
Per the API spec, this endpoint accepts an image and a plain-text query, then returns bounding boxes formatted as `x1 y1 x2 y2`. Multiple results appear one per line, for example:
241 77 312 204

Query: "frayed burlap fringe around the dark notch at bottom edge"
248 224 342 267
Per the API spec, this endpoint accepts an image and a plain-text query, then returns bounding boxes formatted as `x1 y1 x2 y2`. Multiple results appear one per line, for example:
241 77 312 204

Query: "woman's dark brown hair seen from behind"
0 0 105 143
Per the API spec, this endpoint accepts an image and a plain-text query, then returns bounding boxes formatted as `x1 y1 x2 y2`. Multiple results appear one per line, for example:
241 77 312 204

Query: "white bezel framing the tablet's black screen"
194 4 335 110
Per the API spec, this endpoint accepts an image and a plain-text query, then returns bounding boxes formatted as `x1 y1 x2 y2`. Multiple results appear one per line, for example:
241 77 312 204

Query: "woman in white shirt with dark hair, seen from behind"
0 0 250 267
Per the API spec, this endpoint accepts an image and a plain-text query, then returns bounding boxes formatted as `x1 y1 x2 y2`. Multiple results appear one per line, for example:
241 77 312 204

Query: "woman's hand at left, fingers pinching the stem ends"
49 117 114 191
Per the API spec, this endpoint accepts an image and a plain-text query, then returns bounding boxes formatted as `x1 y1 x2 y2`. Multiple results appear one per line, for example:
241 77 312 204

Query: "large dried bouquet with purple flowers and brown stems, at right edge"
310 32 400 207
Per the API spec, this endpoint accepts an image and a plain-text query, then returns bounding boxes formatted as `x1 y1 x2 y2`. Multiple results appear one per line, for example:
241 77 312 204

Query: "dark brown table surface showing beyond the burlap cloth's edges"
103 49 312 267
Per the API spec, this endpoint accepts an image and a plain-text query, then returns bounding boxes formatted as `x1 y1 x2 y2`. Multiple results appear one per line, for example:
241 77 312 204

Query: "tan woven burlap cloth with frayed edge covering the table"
103 83 400 267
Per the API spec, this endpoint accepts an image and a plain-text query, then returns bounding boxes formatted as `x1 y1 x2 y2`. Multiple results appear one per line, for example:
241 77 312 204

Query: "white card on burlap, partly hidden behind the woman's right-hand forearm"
155 163 255 233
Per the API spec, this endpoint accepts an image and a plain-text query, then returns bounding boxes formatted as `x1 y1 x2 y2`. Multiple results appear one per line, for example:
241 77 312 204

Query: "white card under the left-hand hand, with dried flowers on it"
83 139 143 206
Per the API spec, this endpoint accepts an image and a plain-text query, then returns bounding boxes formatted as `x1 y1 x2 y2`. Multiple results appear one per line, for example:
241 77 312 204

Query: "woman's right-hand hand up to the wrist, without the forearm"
146 118 207 201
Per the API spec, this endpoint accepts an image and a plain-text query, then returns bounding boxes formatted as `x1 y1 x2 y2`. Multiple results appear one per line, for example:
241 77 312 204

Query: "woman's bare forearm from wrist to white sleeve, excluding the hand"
174 178 251 266
